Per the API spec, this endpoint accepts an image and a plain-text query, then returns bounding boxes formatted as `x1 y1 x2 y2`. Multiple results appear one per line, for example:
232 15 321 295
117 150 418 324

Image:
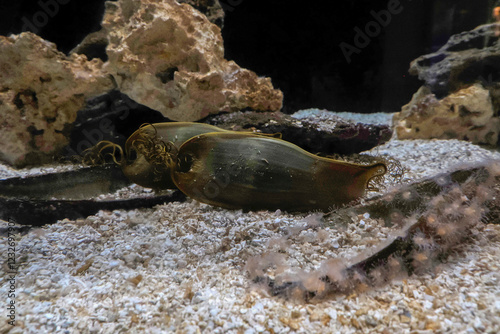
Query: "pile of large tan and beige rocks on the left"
0 0 283 167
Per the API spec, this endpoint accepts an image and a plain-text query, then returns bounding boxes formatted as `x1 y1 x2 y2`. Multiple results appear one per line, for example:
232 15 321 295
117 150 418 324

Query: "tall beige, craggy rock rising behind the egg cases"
102 0 283 121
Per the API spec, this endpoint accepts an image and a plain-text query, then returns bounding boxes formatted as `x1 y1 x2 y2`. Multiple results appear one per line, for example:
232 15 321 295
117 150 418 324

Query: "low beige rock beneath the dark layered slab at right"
393 84 500 145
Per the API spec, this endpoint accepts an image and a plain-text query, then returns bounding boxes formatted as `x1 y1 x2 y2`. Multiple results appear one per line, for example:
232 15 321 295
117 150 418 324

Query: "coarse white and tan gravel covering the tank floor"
0 112 500 333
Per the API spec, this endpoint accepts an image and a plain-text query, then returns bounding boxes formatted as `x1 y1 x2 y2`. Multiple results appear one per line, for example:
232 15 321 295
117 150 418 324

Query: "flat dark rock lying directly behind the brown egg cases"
204 111 392 155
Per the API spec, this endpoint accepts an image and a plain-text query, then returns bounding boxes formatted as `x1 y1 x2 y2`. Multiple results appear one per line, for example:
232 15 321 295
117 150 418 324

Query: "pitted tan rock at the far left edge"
0 33 113 166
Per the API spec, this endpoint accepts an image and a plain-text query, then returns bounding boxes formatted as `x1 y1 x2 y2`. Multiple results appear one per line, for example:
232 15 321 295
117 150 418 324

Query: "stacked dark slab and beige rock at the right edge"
394 24 500 145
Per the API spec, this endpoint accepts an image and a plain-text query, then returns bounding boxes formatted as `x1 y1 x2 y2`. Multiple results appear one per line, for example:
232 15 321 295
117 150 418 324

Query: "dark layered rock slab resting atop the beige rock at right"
410 24 500 98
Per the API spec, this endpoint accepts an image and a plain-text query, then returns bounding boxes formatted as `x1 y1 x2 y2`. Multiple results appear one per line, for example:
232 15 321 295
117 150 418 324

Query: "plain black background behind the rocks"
0 0 494 113
